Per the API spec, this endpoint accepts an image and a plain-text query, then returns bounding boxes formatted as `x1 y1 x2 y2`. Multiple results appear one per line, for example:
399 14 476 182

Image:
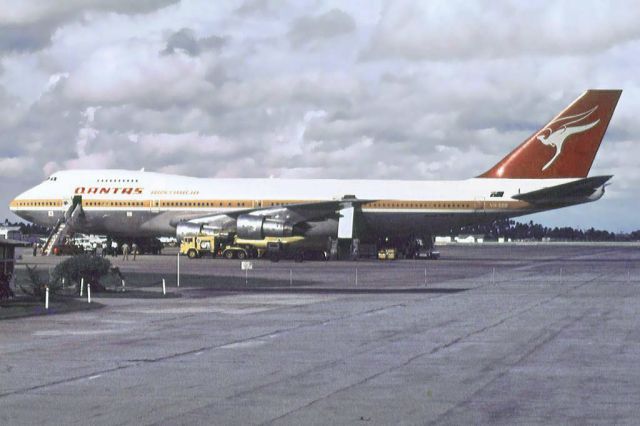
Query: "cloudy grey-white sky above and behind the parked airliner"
0 0 640 232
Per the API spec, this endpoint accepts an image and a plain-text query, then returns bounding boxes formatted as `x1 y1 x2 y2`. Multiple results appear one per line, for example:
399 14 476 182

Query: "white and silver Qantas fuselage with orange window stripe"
10 170 575 236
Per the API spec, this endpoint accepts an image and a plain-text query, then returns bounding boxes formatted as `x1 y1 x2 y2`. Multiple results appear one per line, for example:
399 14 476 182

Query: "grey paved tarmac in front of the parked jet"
0 245 640 425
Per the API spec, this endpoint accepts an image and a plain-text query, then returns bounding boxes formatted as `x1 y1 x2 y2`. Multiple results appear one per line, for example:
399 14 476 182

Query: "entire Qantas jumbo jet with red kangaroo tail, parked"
10 90 622 256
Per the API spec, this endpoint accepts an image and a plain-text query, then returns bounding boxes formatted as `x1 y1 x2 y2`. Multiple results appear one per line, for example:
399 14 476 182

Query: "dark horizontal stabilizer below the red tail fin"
513 176 613 204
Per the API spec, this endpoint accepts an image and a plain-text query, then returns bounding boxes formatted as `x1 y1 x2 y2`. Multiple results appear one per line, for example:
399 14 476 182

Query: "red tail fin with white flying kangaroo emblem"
478 90 622 179
